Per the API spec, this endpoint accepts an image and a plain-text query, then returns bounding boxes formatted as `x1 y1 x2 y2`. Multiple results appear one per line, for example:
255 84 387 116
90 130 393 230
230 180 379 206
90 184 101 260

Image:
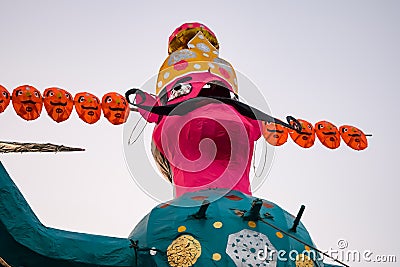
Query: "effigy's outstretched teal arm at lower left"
0 162 136 267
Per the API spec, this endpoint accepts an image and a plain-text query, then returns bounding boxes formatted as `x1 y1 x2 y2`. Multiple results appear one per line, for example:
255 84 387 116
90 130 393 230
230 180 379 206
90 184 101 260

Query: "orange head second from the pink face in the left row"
74 92 101 124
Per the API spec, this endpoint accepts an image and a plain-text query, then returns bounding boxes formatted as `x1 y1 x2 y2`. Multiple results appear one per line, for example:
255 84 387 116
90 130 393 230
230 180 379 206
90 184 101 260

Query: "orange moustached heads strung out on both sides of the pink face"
0 82 368 150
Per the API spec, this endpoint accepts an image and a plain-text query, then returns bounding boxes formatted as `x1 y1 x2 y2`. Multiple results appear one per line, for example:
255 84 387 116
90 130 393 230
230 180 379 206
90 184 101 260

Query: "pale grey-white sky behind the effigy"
0 0 400 266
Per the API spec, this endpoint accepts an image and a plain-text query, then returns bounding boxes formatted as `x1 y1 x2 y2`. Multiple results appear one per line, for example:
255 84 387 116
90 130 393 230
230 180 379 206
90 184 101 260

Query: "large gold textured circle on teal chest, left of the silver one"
167 235 201 267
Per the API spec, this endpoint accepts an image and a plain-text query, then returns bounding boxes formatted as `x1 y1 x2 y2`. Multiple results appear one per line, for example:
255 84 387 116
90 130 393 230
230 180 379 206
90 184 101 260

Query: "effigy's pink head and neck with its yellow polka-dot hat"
148 23 260 199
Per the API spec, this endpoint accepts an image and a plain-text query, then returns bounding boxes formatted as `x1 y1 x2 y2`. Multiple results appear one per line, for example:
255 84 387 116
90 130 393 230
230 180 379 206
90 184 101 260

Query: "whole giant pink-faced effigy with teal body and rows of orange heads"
0 23 368 267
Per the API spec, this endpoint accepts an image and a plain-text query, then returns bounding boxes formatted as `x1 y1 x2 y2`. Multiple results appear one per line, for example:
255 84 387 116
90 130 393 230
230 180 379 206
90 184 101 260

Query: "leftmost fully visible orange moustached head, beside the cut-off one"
12 85 43 121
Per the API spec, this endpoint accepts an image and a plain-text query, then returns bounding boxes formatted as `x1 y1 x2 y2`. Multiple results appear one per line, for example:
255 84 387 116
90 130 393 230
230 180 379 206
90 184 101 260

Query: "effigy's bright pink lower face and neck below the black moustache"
153 101 261 197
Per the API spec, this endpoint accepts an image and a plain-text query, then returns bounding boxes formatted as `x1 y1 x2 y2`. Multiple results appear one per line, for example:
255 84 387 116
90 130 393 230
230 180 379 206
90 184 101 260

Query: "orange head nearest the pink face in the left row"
101 92 129 125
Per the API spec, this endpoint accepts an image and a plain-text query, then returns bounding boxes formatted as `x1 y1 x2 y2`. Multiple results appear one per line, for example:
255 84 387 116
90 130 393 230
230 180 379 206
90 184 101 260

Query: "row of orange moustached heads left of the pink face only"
0 85 130 125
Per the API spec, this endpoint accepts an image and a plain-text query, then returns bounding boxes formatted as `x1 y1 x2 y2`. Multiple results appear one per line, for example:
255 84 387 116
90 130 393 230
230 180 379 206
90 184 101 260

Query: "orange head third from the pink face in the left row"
43 87 74 122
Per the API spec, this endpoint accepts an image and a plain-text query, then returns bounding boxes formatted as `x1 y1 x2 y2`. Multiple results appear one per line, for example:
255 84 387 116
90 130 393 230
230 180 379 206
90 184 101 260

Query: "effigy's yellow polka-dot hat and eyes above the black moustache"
156 23 238 105
